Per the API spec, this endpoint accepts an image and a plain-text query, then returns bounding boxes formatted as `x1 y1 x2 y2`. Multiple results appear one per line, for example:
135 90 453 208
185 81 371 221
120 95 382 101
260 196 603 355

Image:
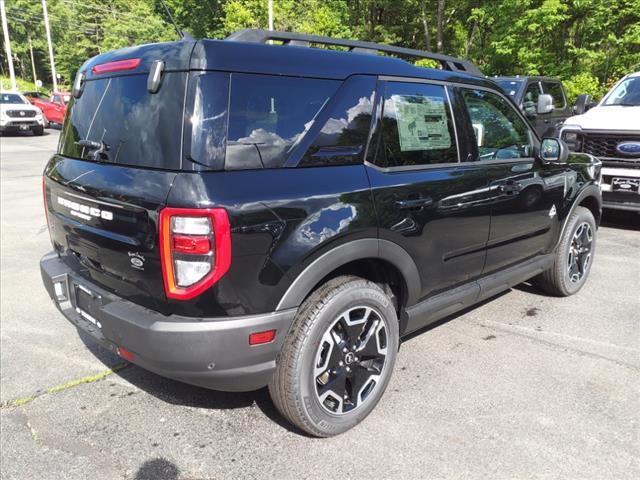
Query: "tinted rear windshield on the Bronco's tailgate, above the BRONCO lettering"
60 72 186 170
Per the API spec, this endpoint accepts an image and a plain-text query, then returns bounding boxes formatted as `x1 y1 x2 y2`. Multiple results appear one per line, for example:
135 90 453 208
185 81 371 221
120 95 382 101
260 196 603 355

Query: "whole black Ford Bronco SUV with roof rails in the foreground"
40 30 601 436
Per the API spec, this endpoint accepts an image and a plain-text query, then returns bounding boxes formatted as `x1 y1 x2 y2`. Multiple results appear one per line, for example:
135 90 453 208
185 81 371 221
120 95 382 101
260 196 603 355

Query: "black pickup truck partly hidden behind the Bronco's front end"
492 76 575 137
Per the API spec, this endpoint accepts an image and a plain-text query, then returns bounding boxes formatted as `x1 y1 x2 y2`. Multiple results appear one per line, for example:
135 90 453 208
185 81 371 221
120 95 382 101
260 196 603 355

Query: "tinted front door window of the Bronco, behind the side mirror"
461 88 532 160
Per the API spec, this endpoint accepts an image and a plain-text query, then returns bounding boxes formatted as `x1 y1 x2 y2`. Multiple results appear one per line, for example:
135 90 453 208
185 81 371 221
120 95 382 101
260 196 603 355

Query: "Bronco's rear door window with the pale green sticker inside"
376 83 458 167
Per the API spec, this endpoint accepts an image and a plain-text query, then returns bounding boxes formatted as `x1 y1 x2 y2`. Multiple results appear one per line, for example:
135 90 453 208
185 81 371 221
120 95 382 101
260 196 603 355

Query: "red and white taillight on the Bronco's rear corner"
159 207 231 300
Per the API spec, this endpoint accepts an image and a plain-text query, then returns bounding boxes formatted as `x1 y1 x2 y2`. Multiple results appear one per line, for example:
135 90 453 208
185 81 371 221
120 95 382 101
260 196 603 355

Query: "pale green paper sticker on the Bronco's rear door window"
391 95 451 152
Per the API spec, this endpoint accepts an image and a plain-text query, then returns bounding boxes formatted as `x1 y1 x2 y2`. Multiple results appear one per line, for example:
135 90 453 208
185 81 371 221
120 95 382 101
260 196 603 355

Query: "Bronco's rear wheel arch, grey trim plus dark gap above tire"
276 239 421 310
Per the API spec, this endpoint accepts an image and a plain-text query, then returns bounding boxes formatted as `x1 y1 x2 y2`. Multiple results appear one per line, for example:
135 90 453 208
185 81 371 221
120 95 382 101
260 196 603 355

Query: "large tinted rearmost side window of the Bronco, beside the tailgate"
225 73 340 170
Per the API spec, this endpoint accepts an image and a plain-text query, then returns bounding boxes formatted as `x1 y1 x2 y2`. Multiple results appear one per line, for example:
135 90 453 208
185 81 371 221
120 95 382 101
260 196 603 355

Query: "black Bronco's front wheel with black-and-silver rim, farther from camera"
538 207 596 297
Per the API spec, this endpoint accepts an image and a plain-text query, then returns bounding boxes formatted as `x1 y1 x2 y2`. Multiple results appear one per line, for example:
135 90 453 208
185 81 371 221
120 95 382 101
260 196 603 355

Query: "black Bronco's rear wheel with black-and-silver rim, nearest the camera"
269 276 399 437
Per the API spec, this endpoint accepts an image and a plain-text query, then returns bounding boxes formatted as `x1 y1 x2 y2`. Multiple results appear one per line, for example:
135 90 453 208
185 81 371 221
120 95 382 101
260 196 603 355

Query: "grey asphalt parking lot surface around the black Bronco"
0 130 640 480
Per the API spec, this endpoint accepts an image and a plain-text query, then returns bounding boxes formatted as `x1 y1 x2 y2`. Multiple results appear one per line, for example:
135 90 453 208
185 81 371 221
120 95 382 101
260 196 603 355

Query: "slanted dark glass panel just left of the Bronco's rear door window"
300 77 376 166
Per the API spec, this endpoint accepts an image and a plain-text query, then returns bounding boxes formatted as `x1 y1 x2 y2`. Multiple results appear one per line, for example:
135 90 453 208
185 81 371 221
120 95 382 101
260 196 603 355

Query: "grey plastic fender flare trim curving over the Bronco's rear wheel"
276 238 422 310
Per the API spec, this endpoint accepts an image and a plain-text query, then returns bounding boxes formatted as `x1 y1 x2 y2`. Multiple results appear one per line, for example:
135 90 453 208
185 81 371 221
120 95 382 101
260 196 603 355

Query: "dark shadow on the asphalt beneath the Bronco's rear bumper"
78 330 307 436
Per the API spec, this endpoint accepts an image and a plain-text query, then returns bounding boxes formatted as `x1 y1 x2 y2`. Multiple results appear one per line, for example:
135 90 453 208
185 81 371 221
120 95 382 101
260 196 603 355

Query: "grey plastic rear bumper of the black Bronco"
40 252 296 391
